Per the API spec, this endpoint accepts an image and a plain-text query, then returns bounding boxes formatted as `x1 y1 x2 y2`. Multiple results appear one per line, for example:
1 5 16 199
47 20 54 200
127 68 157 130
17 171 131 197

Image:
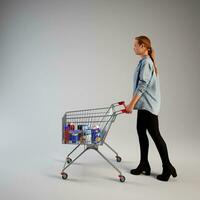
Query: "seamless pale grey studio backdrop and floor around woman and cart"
0 0 200 199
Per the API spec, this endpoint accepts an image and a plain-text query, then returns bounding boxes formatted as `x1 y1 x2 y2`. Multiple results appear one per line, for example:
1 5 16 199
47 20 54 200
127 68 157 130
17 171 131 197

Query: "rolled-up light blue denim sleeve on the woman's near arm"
134 61 153 96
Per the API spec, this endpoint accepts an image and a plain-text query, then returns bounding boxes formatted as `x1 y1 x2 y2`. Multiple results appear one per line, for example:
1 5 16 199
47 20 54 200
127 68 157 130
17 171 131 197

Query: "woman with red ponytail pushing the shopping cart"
126 36 177 181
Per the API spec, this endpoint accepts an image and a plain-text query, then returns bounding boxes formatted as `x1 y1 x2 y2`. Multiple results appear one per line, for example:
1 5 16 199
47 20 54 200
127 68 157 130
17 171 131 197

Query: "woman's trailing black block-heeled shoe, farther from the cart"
157 165 177 181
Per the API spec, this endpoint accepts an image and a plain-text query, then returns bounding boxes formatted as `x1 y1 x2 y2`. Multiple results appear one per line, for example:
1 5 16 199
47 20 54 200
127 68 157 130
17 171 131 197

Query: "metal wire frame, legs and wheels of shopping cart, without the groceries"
61 101 126 182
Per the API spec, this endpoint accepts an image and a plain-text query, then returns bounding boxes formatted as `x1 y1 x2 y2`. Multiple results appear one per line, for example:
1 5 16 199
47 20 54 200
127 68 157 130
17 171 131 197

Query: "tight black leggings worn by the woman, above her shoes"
137 110 170 166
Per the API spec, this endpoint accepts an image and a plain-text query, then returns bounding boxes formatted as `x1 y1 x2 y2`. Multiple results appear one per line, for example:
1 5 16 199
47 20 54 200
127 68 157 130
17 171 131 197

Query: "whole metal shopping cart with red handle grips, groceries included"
61 101 126 182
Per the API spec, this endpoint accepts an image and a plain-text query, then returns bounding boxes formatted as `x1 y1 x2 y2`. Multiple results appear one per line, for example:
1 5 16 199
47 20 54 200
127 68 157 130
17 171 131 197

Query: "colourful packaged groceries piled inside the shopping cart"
63 123 104 144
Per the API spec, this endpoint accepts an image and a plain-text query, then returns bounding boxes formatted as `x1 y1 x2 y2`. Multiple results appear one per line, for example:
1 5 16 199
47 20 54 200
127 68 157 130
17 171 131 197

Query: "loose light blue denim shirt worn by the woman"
133 56 161 115
